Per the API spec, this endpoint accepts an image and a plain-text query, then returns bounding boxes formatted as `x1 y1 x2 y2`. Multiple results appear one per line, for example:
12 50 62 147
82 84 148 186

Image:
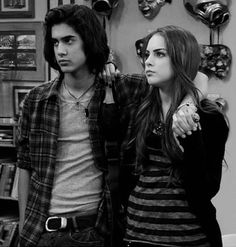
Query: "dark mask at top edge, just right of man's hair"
92 0 119 16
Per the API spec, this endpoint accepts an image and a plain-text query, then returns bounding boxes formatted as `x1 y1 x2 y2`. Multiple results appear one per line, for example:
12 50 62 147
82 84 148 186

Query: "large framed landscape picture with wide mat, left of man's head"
0 22 45 82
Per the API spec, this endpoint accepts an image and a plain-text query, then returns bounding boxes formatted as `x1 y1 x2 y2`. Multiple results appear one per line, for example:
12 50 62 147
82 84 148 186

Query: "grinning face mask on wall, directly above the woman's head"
138 0 172 19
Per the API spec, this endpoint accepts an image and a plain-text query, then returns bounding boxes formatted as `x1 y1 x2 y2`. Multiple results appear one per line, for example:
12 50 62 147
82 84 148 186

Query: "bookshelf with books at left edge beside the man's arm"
0 118 19 247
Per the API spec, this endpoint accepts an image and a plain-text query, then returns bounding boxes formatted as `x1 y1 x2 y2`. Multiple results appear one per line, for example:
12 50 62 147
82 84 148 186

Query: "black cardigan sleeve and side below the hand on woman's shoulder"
180 108 229 247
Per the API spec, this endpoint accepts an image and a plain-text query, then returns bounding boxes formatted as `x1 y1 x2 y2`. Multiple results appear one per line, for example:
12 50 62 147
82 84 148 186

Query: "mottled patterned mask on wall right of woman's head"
200 44 232 79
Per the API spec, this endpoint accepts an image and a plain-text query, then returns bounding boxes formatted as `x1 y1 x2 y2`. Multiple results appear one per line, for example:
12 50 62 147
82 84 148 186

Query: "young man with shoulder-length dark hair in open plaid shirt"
18 5 115 247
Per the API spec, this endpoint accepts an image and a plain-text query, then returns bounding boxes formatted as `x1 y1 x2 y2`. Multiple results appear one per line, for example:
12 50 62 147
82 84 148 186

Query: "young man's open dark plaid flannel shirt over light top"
17 79 113 247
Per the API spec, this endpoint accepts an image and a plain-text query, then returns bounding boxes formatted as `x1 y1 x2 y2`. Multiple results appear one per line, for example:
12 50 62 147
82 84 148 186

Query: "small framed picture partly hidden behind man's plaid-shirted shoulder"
13 86 33 117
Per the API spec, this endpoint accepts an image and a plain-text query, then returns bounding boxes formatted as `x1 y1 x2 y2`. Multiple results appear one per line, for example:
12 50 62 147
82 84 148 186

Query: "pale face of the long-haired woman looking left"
145 34 174 88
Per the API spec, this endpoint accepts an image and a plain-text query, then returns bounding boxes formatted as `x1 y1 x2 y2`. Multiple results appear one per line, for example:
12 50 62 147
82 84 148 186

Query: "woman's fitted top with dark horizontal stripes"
125 131 209 247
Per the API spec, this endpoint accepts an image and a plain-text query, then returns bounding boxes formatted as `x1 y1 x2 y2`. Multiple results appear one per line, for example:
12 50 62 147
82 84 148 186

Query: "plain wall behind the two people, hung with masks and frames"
0 0 236 233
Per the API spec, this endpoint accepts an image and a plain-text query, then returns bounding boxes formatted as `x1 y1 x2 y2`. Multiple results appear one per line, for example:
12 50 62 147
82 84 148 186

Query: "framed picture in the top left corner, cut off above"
0 0 35 18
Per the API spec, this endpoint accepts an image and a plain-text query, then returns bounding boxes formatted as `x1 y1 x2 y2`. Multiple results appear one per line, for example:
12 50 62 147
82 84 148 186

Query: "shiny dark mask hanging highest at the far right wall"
183 0 230 28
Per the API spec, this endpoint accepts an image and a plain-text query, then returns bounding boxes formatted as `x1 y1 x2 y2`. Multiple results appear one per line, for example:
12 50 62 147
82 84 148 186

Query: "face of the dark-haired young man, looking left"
52 23 88 73
